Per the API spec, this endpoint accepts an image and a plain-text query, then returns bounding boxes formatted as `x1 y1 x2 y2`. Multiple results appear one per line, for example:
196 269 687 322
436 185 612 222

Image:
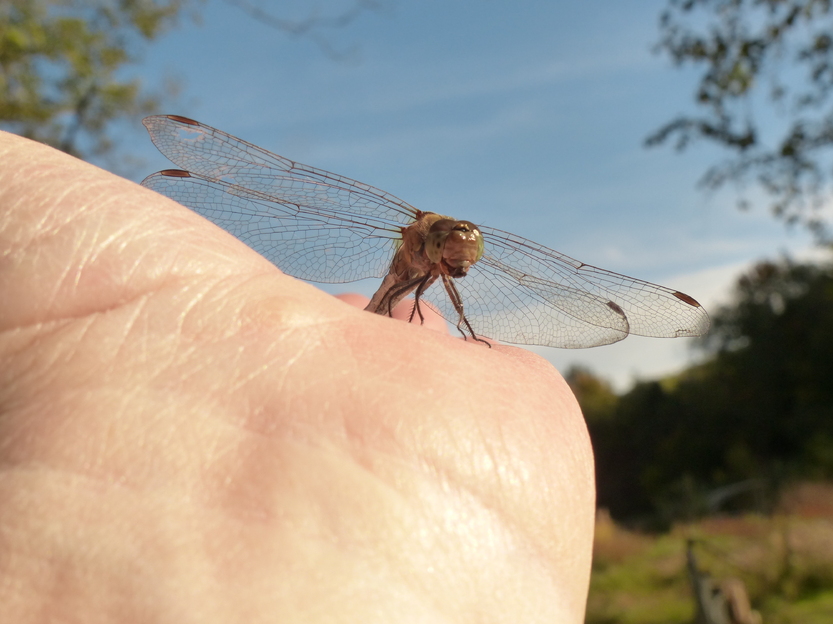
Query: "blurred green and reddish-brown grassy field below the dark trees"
586 484 833 624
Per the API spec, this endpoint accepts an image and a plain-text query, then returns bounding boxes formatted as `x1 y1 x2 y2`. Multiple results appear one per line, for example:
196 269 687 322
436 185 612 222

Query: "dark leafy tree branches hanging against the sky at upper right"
646 0 833 240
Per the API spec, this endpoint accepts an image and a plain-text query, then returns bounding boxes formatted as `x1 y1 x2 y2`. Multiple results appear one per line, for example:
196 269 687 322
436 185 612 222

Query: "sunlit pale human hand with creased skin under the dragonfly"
0 133 594 624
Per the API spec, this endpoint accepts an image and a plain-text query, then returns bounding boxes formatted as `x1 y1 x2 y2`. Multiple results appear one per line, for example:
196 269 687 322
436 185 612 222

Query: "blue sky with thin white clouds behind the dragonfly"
121 0 824 389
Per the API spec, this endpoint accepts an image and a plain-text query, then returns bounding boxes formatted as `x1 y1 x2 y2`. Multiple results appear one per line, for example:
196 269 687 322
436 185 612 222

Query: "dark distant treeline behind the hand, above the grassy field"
567 260 833 526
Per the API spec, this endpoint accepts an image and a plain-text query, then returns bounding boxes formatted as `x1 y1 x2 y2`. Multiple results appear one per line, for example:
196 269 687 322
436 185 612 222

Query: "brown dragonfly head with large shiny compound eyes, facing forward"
425 219 483 277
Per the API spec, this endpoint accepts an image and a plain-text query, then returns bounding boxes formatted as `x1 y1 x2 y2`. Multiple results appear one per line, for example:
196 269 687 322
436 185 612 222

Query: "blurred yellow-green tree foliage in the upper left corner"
0 0 197 156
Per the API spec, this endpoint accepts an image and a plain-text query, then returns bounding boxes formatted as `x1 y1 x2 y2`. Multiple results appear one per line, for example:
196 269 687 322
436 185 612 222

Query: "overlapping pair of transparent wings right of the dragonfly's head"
425 228 709 348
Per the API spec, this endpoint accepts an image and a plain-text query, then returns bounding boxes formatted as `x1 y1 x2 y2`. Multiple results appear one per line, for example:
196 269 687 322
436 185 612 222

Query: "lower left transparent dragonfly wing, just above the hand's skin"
142 171 401 283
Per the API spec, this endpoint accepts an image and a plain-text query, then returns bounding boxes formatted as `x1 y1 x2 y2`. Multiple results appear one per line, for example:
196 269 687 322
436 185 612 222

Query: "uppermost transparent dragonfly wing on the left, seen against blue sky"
142 115 418 225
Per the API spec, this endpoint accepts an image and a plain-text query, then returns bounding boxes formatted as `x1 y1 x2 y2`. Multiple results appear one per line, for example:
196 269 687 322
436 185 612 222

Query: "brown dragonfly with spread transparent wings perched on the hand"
142 115 710 348
